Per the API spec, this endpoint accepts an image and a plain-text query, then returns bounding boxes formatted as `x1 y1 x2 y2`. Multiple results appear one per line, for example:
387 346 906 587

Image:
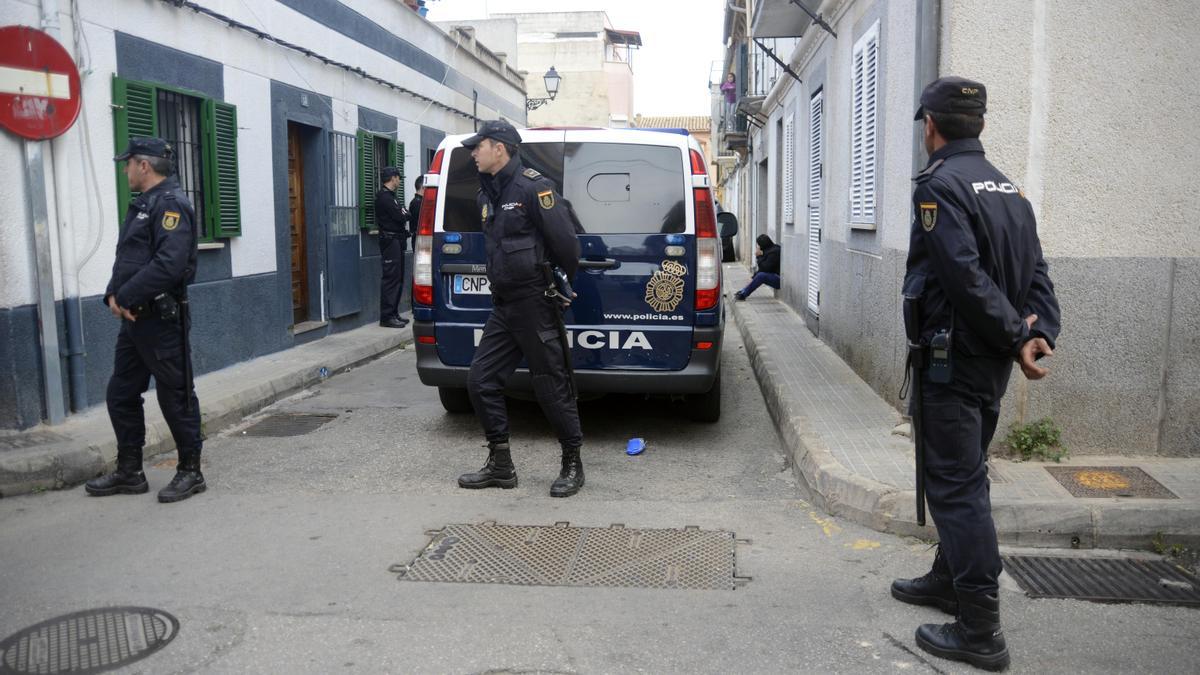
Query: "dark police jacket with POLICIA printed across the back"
904 138 1061 357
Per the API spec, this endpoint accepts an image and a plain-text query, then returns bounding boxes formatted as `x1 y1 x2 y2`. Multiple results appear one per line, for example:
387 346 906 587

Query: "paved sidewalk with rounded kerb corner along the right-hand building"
725 264 1200 548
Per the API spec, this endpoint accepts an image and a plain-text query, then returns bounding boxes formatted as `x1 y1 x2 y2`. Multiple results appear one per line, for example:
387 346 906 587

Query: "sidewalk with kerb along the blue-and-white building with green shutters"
0 327 413 497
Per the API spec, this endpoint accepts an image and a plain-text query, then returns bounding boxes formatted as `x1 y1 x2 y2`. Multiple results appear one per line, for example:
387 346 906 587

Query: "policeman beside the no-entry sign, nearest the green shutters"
86 137 206 502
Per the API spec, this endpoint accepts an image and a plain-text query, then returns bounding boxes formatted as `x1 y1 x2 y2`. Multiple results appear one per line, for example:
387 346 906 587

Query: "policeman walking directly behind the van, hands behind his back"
458 120 583 497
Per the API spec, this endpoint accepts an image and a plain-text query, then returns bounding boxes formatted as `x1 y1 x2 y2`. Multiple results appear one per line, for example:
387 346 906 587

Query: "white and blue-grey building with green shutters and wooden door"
0 0 524 429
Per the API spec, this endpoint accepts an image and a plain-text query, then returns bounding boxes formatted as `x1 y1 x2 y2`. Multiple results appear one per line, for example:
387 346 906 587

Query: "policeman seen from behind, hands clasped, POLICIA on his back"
892 77 1060 670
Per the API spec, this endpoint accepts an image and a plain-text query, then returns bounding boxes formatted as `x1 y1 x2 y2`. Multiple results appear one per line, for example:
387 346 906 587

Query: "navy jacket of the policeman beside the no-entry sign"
103 177 199 309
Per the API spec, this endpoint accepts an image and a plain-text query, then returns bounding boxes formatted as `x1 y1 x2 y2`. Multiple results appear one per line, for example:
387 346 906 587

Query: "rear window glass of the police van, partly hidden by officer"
443 143 688 234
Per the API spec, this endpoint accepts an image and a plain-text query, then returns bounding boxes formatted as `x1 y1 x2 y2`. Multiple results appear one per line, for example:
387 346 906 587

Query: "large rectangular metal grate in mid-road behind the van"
392 524 740 591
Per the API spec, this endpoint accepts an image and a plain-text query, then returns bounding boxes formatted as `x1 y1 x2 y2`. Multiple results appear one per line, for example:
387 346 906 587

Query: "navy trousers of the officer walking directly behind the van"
467 294 583 448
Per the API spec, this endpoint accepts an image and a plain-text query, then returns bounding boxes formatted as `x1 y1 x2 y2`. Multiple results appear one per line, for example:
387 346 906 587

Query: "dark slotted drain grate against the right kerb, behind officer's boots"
1003 556 1200 607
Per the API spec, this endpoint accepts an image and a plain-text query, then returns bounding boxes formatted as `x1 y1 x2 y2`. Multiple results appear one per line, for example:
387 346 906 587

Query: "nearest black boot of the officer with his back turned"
917 593 1008 670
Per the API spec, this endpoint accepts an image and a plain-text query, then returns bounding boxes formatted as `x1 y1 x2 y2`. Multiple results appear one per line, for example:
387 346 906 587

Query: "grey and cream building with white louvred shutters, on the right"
714 0 1200 456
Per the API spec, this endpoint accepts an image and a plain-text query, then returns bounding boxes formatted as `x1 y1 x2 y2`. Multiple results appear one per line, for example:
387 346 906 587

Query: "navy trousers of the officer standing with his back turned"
922 353 1013 593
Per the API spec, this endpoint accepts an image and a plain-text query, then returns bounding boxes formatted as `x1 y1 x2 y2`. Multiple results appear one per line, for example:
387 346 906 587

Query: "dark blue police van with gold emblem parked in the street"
412 129 736 422
